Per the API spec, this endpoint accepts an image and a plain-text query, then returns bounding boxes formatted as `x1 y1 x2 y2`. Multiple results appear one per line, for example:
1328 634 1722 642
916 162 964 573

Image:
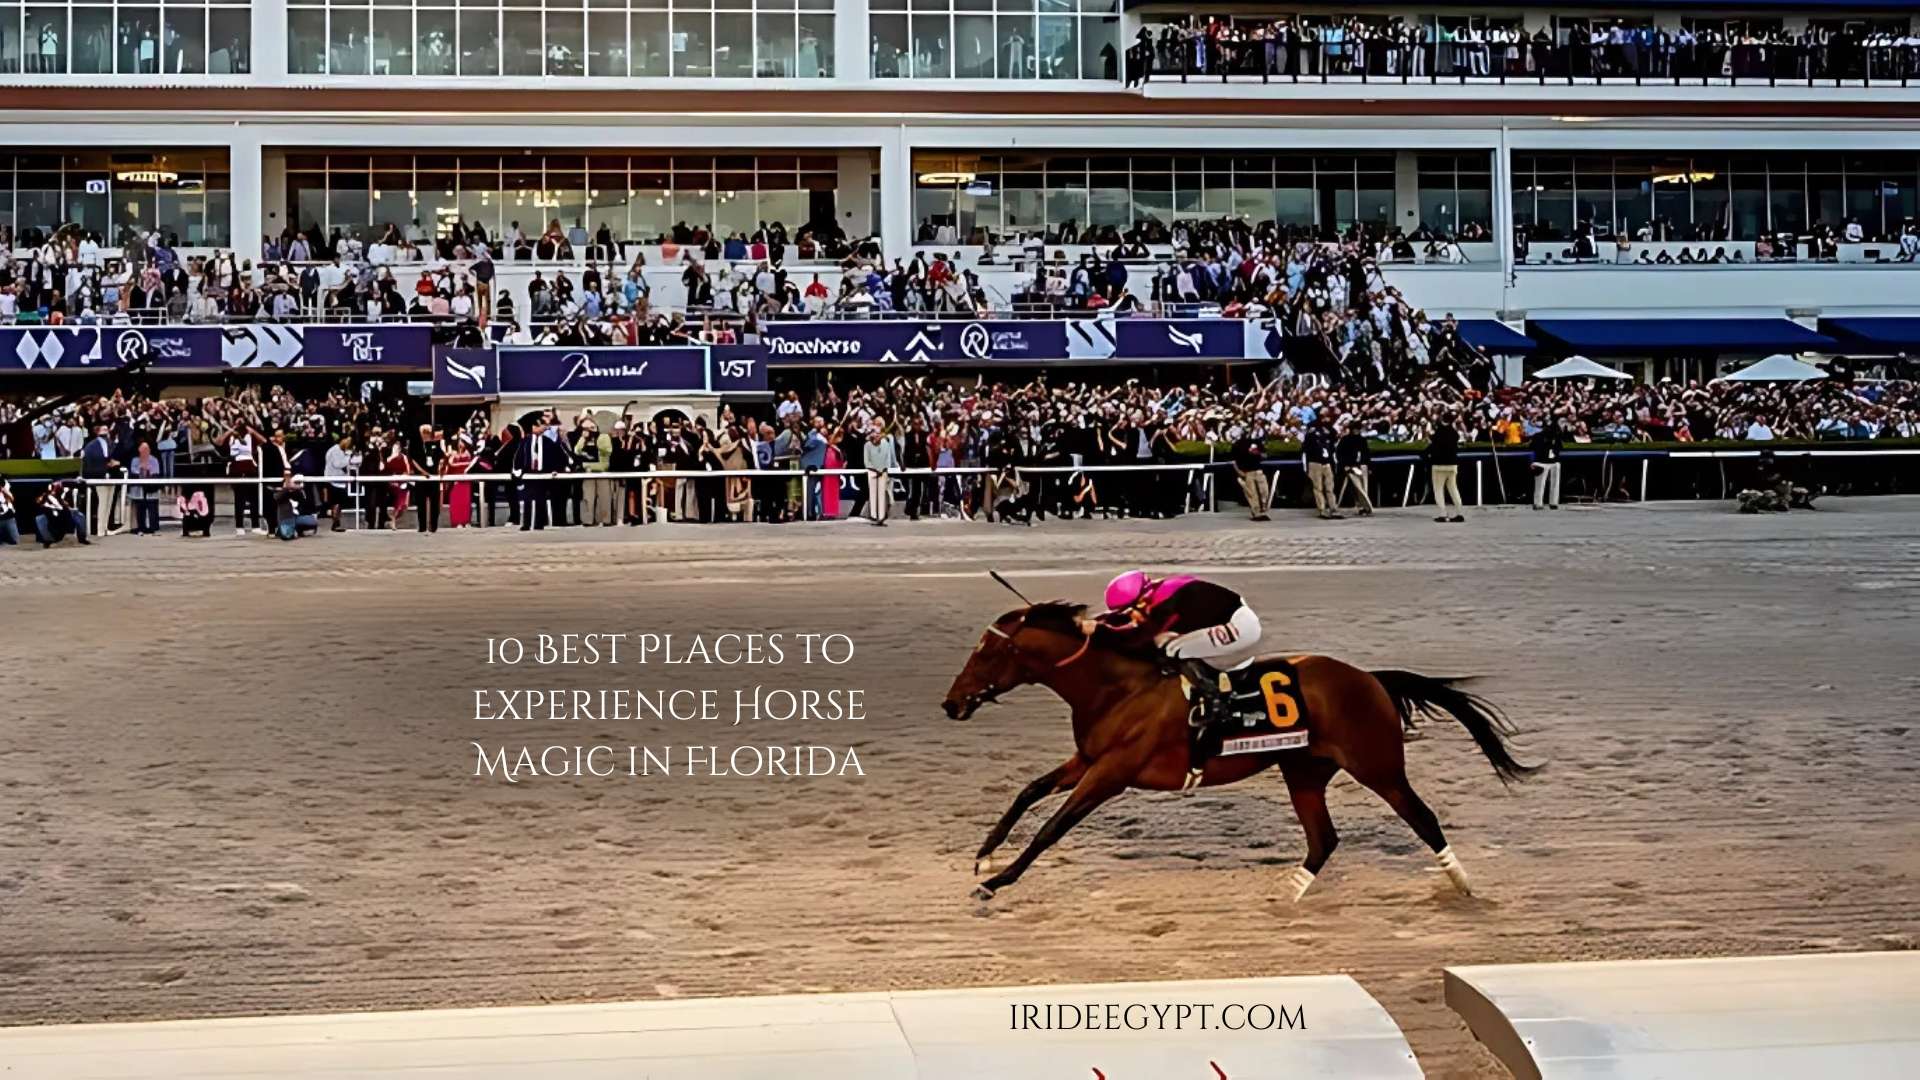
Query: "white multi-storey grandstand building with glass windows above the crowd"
0 0 1920 378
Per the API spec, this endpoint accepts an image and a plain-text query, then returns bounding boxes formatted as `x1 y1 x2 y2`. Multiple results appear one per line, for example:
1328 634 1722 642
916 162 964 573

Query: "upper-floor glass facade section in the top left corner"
0 0 253 75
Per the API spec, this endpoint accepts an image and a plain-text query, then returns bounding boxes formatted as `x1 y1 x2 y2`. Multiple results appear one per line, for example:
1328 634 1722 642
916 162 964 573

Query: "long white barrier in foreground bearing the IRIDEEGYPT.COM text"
0 976 1421 1080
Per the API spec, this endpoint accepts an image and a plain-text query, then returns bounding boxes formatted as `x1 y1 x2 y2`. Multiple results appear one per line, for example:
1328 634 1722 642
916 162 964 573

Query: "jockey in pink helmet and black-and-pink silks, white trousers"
1100 571 1260 728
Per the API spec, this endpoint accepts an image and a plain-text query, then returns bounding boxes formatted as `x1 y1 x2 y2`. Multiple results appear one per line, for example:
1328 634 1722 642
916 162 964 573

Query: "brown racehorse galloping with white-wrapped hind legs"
943 601 1534 899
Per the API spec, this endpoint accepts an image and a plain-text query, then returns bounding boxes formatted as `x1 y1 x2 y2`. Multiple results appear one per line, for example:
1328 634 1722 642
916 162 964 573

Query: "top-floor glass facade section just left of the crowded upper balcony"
870 0 1125 81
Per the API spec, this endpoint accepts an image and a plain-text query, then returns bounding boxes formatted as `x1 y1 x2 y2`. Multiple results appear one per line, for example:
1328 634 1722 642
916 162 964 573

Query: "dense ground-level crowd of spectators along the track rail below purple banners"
0 363 1920 542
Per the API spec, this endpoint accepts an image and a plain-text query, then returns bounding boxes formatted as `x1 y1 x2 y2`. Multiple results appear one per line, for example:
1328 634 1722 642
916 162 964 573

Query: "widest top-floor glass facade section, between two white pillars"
286 0 833 79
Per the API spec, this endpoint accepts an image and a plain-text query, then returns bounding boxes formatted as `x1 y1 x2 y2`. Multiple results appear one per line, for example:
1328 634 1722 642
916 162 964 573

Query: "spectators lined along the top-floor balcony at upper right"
1127 15 1920 83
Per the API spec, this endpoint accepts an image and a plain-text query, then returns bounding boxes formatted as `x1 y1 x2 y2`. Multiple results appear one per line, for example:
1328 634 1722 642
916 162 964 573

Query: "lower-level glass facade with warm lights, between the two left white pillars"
286 154 839 242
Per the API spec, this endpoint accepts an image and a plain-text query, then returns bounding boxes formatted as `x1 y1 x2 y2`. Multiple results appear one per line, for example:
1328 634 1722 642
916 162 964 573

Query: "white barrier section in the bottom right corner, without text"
1446 953 1920 1080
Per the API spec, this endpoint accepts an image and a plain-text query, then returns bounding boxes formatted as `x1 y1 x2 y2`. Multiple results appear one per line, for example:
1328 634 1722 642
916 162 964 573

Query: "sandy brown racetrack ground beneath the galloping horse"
0 500 1920 1078
